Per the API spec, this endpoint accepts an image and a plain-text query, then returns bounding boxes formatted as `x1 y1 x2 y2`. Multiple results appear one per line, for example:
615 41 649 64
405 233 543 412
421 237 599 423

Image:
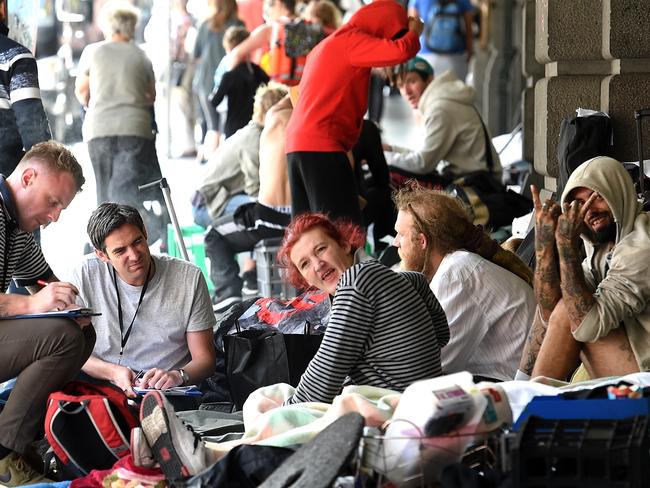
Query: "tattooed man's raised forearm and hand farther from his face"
530 185 562 320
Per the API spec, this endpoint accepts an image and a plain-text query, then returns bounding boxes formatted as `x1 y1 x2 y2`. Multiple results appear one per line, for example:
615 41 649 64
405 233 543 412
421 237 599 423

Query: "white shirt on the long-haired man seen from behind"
431 251 535 380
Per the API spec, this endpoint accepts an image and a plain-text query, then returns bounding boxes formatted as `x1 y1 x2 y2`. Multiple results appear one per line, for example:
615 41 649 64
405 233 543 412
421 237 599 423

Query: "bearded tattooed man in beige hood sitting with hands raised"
518 156 650 379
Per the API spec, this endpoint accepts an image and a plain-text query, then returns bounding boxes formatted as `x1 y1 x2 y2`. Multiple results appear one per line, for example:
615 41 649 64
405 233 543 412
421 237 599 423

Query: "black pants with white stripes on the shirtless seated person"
205 202 290 300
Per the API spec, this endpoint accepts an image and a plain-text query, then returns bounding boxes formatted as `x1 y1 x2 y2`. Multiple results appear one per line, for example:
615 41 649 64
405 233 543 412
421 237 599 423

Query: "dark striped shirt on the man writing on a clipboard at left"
0 176 52 291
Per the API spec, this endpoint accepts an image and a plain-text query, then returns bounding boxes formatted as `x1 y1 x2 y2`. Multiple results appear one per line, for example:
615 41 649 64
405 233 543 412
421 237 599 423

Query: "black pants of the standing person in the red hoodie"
287 152 362 224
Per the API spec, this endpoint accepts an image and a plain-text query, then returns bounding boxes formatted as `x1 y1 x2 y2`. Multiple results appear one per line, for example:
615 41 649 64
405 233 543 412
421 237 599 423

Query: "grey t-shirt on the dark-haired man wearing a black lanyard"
69 254 216 371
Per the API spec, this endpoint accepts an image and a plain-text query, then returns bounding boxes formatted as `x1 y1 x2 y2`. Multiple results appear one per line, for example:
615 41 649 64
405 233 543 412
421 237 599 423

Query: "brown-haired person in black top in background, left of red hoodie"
210 26 269 138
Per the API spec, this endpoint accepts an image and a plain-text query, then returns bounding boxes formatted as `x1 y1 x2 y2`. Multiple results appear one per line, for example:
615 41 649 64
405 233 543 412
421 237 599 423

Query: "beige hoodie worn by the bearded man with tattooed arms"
562 156 650 371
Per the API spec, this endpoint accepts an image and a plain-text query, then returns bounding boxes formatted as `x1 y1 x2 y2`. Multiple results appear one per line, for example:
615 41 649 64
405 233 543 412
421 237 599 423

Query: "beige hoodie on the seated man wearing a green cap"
389 71 502 181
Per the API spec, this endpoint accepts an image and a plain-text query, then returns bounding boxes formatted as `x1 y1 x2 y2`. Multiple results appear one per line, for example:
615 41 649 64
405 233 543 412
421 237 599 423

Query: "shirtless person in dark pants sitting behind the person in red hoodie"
205 95 292 312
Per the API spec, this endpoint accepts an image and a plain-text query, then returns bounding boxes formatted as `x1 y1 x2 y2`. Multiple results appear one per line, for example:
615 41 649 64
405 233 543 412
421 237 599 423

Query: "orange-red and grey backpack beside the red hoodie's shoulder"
268 19 325 86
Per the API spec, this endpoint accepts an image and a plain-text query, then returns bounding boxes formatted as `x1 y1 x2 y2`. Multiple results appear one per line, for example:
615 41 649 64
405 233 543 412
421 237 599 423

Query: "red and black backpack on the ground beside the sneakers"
45 381 139 475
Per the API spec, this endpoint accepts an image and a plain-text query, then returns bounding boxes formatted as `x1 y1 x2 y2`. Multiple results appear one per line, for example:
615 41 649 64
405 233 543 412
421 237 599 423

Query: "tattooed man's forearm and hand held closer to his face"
555 192 597 331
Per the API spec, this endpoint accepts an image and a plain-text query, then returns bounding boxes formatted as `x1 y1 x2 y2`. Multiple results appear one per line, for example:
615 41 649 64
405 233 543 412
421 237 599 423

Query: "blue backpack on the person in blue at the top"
424 0 466 54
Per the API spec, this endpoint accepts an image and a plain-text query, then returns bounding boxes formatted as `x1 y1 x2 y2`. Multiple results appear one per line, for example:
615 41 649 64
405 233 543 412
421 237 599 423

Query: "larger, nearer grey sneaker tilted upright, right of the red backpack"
140 391 213 480
